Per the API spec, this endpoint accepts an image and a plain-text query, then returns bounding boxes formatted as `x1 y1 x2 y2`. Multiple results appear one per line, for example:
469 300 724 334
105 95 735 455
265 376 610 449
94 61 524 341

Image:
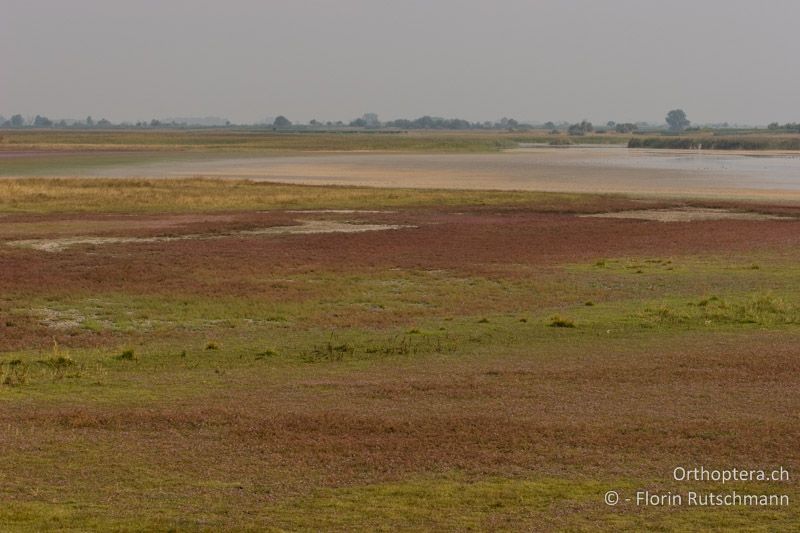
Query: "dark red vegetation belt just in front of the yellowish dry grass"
0 210 800 294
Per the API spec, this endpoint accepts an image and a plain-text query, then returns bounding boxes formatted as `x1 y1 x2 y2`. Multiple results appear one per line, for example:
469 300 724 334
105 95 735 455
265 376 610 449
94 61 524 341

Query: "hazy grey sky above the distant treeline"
0 0 800 124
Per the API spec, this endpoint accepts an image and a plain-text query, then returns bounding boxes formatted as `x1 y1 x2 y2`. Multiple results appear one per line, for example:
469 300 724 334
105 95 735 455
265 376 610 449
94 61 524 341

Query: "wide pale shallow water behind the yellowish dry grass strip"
42 146 800 199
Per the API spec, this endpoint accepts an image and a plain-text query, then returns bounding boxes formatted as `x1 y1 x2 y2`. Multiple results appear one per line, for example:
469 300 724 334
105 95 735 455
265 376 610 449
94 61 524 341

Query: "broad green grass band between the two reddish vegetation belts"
6 250 800 401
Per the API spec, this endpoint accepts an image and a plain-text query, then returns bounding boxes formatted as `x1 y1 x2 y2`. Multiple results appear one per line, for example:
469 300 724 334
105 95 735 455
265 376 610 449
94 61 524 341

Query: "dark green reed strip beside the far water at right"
628 135 800 150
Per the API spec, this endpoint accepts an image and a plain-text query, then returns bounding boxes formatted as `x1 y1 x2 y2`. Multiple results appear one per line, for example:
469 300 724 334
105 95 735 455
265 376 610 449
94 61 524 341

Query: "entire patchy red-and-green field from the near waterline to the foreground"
0 167 800 531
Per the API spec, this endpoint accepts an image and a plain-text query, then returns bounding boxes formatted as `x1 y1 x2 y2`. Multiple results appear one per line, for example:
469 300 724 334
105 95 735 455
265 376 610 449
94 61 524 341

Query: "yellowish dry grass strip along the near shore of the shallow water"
0 178 633 213
